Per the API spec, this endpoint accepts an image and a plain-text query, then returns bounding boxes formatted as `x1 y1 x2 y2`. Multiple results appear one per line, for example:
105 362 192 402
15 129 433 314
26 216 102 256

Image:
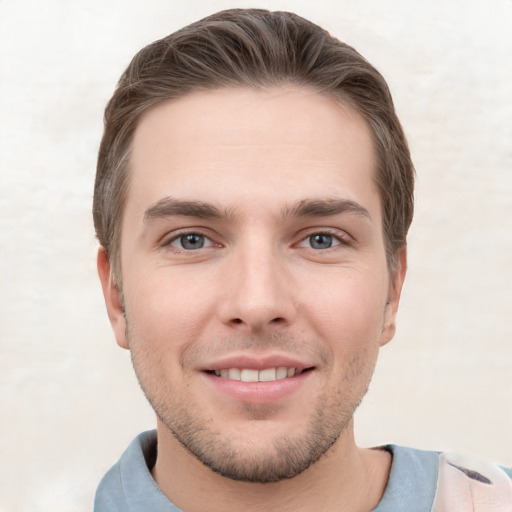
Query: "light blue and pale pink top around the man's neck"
94 430 512 512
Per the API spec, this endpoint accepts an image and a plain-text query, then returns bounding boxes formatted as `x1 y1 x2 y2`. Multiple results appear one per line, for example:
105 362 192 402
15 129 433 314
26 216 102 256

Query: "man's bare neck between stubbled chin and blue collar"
152 421 391 512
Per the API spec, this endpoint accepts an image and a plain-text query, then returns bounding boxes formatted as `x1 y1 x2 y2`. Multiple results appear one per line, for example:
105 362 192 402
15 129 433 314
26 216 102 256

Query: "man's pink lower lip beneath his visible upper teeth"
203 370 313 404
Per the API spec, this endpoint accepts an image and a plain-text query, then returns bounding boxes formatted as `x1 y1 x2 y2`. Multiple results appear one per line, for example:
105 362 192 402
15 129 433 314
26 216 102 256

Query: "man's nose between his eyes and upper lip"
218 239 296 333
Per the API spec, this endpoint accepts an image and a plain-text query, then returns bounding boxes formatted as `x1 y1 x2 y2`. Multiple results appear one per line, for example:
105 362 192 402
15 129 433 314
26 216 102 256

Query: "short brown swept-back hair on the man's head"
93 9 414 283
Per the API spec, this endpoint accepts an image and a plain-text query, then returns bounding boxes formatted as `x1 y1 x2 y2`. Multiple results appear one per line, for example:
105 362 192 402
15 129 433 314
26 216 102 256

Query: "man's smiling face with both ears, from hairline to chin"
98 87 405 482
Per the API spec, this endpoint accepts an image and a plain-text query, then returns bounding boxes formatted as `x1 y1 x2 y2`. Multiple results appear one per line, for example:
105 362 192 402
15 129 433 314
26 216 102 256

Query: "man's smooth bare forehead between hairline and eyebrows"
126 87 378 219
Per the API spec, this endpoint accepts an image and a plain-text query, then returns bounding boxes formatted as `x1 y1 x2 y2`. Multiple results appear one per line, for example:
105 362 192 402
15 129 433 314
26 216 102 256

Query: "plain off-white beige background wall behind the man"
0 0 512 512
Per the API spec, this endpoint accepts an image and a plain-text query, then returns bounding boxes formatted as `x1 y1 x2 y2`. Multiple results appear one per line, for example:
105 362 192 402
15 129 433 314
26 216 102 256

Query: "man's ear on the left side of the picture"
97 247 128 349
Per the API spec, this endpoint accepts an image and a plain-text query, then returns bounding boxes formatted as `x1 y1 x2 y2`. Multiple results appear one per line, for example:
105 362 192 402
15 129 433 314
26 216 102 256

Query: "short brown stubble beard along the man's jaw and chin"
127 329 373 483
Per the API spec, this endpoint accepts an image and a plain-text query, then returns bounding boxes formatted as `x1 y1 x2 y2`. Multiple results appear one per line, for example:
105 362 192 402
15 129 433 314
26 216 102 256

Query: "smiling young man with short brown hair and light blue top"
94 10 512 512
